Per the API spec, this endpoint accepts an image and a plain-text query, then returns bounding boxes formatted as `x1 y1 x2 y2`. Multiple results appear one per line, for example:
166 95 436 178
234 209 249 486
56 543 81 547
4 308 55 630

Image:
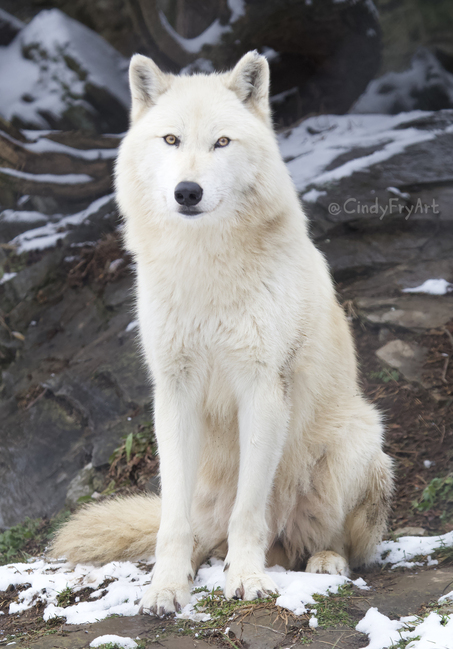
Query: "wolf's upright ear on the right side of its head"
228 50 269 116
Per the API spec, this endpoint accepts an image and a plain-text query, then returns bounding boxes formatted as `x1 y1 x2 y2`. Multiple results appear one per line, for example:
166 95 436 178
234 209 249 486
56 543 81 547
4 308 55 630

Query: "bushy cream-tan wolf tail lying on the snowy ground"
50 495 161 564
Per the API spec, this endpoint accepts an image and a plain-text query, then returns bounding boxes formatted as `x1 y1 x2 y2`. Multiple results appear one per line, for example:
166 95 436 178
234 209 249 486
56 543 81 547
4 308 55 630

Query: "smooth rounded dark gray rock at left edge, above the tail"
0 391 91 528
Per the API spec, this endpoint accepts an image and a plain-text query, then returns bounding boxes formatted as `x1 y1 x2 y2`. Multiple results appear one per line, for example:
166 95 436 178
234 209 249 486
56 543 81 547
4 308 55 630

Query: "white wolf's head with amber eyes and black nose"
117 52 294 230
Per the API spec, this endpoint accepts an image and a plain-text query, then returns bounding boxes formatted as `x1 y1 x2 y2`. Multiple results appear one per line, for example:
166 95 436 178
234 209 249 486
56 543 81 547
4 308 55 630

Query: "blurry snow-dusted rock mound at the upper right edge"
350 48 453 115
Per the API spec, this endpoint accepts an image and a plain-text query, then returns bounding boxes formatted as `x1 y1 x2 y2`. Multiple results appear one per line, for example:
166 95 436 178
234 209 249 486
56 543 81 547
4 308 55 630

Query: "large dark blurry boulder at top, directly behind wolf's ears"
124 0 380 124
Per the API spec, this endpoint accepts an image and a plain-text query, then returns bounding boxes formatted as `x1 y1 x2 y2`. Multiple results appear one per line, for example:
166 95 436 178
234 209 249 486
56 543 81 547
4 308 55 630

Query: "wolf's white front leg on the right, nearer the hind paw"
225 377 290 600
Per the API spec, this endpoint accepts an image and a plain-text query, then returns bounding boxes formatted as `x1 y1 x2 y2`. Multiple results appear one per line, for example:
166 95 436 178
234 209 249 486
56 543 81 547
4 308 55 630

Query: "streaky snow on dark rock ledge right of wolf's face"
278 111 438 192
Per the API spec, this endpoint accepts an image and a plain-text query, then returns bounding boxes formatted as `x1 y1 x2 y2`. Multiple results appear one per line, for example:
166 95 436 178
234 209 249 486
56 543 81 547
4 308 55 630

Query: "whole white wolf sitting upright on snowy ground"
54 52 392 614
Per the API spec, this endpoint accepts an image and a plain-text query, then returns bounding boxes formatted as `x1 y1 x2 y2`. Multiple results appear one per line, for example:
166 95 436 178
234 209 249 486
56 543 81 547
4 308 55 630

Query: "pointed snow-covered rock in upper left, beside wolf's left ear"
0 9 129 128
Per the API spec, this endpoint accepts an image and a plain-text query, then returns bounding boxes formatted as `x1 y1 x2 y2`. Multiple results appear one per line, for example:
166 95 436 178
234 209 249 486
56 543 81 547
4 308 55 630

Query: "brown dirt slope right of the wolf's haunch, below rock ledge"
353 319 453 534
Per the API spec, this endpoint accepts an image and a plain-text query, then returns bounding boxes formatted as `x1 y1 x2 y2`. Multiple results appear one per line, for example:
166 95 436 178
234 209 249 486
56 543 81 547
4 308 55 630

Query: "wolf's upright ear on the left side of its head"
129 54 171 122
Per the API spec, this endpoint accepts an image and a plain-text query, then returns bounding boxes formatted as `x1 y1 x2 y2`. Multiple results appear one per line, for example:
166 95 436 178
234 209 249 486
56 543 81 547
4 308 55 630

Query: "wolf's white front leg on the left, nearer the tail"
140 382 202 615
